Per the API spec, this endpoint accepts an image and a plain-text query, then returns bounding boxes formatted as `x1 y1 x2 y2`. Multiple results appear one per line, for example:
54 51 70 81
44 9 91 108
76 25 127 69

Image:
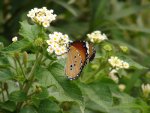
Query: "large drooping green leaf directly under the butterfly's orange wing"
48 63 84 107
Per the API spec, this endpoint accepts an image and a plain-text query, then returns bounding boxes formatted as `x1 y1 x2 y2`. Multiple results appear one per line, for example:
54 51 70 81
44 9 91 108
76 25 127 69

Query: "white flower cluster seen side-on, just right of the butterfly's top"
87 31 108 43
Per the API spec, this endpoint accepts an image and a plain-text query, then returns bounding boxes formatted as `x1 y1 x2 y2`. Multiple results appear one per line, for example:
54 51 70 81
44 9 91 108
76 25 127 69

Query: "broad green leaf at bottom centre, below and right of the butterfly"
81 81 113 112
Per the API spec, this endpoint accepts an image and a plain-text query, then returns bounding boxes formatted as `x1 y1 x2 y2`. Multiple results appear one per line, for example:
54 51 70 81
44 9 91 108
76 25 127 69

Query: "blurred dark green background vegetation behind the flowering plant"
0 0 150 113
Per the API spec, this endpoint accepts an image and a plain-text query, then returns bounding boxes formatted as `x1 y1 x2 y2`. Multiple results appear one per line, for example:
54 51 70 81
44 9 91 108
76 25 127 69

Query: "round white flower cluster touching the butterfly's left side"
46 32 70 56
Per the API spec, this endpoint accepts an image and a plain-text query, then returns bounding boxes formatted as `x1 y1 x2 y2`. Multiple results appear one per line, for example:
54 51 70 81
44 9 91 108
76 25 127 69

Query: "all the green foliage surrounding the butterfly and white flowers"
0 0 150 113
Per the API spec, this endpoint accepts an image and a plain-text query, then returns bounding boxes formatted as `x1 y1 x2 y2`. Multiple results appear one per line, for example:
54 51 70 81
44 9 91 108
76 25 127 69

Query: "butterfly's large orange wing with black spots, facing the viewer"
65 42 86 80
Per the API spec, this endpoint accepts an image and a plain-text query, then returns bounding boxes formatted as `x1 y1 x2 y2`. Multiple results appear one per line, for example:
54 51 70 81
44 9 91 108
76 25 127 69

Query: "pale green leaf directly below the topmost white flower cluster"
19 21 41 41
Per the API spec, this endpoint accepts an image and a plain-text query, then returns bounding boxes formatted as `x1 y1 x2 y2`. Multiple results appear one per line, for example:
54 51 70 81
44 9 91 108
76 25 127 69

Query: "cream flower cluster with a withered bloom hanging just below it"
108 56 129 69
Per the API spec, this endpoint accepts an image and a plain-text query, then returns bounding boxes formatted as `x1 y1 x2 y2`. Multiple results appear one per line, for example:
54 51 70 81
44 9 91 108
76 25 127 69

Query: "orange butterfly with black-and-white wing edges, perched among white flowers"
65 41 96 80
